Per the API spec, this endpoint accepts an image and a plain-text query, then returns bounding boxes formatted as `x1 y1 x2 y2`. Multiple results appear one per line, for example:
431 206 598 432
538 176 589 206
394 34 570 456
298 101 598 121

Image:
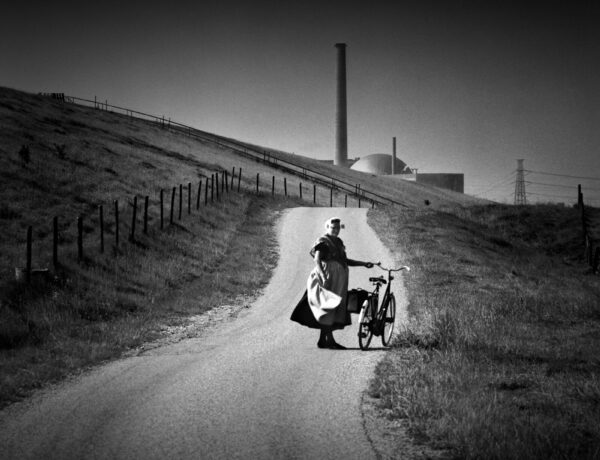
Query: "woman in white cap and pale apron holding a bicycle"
291 217 373 350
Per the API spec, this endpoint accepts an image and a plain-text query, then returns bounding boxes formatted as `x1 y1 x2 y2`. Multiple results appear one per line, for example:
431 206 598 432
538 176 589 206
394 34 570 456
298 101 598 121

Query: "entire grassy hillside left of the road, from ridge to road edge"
0 88 478 410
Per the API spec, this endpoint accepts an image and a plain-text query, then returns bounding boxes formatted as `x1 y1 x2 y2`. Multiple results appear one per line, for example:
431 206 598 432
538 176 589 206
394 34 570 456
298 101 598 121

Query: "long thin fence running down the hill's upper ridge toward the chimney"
58 93 408 207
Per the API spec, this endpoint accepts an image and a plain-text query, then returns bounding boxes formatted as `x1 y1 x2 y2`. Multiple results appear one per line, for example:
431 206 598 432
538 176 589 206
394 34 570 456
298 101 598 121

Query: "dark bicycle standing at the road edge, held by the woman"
358 263 410 350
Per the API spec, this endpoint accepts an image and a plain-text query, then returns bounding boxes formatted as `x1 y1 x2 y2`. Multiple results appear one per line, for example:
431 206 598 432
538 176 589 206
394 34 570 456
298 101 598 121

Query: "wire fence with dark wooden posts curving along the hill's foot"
15 167 376 283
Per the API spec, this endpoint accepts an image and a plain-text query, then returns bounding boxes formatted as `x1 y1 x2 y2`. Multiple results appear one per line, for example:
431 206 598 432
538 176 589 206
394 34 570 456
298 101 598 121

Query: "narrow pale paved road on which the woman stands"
0 208 405 460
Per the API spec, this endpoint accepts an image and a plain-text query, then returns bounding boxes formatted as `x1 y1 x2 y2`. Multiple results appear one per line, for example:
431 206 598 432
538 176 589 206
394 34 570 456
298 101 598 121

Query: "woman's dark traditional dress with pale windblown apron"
290 235 352 330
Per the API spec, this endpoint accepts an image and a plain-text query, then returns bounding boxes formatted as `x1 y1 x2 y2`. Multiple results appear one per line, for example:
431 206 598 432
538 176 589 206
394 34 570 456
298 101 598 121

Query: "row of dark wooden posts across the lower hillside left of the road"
21 167 375 283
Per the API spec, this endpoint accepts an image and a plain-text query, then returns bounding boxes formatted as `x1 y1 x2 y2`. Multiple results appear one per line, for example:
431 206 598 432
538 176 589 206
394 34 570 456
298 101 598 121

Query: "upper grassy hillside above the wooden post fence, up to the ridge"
0 88 473 279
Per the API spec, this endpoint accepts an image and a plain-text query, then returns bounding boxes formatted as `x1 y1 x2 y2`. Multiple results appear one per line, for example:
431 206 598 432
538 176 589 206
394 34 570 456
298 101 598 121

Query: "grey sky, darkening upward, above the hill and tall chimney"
0 0 600 206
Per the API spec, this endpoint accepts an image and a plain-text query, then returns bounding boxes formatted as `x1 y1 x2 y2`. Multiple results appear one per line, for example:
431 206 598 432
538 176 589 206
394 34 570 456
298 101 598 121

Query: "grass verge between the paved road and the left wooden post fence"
0 195 291 404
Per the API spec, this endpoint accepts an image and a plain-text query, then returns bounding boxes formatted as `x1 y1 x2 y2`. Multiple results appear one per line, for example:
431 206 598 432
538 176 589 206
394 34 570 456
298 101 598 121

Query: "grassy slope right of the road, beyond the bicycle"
370 206 600 459
